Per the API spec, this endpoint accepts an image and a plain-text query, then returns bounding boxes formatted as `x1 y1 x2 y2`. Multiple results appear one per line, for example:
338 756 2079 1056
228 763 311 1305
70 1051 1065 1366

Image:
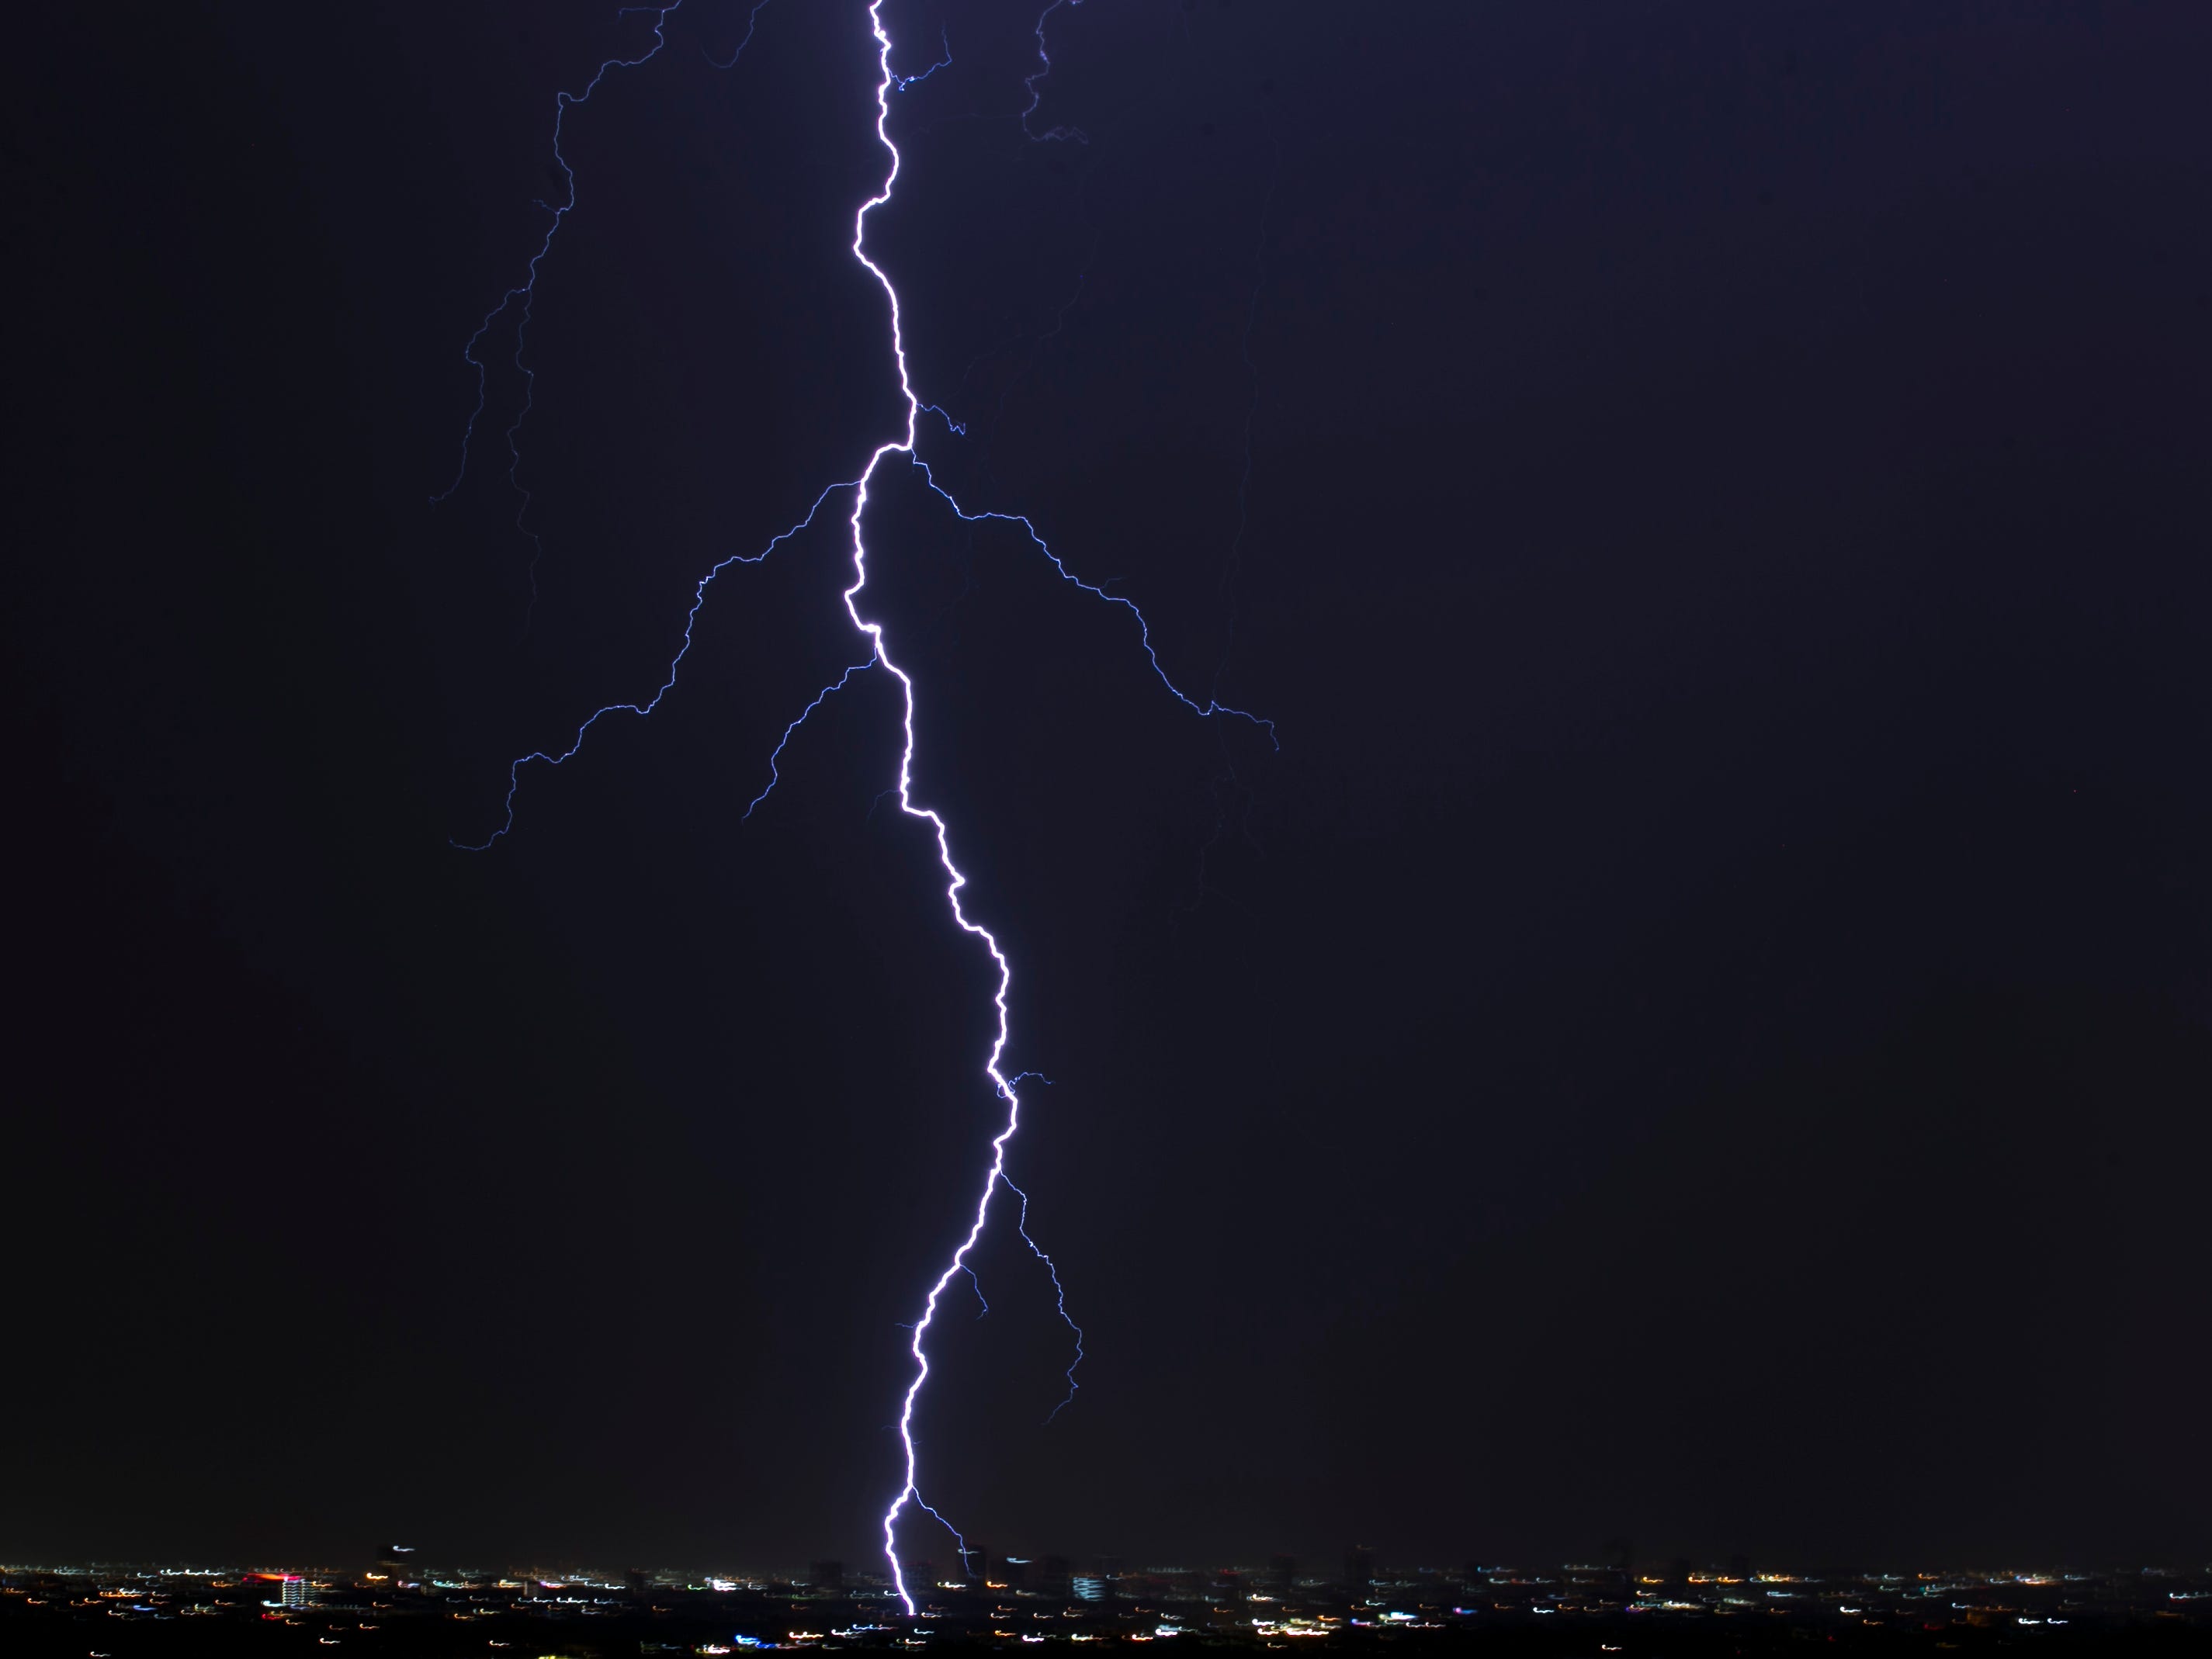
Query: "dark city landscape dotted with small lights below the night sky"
0 1566 2212 1659
